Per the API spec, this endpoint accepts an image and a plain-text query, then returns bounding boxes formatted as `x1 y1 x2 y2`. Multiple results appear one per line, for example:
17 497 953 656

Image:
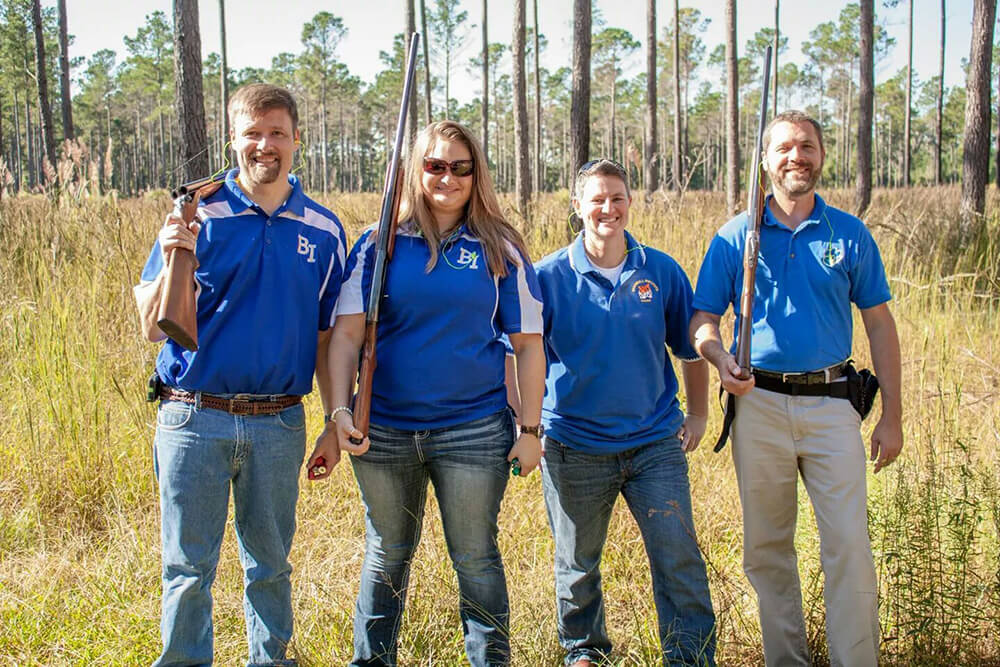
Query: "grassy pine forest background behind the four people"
0 0 1000 665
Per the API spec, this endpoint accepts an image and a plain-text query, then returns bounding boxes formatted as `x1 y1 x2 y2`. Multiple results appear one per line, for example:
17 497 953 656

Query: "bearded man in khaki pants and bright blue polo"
691 111 903 666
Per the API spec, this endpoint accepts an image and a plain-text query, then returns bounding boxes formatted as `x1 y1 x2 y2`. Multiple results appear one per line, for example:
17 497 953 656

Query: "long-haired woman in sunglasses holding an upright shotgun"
308 121 545 666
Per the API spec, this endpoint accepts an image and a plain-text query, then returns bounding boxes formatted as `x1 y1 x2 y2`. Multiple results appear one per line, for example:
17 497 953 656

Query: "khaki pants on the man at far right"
732 389 879 667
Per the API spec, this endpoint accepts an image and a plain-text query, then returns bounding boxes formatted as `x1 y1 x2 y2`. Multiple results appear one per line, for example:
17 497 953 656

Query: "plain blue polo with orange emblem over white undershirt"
535 232 698 454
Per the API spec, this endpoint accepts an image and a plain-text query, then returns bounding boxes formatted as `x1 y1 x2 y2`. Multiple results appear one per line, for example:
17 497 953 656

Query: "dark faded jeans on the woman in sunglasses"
351 409 514 667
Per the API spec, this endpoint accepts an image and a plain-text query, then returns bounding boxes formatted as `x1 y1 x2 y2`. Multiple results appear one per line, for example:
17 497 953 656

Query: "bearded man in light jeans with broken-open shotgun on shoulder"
136 84 346 665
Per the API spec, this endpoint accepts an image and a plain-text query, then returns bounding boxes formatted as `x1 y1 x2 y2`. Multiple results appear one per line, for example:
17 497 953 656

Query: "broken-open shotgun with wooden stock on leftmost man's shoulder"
156 179 223 352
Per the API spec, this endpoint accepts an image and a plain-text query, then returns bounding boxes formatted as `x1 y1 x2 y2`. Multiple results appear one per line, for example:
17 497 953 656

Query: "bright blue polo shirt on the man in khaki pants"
694 195 892 373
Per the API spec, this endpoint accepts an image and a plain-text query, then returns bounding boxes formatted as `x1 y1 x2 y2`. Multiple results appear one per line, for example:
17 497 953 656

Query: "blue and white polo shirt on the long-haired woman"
337 222 542 430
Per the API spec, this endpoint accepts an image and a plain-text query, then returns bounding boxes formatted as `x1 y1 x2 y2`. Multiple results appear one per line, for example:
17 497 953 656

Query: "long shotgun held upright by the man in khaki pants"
715 46 771 451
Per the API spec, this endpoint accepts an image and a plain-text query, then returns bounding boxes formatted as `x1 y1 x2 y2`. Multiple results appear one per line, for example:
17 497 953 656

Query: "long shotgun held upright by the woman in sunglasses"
351 32 420 445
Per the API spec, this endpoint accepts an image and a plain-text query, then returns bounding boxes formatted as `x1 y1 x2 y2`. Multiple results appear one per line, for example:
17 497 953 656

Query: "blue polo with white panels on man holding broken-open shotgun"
142 170 347 395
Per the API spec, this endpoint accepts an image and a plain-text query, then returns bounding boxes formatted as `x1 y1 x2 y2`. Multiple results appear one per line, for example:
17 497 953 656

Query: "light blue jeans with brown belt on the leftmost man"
154 401 306 667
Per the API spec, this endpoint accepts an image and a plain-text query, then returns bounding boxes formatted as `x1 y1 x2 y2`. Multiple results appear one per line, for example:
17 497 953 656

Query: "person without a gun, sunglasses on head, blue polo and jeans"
536 160 715 667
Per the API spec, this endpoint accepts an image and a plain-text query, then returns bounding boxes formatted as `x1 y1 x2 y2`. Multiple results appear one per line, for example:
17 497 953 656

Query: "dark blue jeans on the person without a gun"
542 437 715 665
